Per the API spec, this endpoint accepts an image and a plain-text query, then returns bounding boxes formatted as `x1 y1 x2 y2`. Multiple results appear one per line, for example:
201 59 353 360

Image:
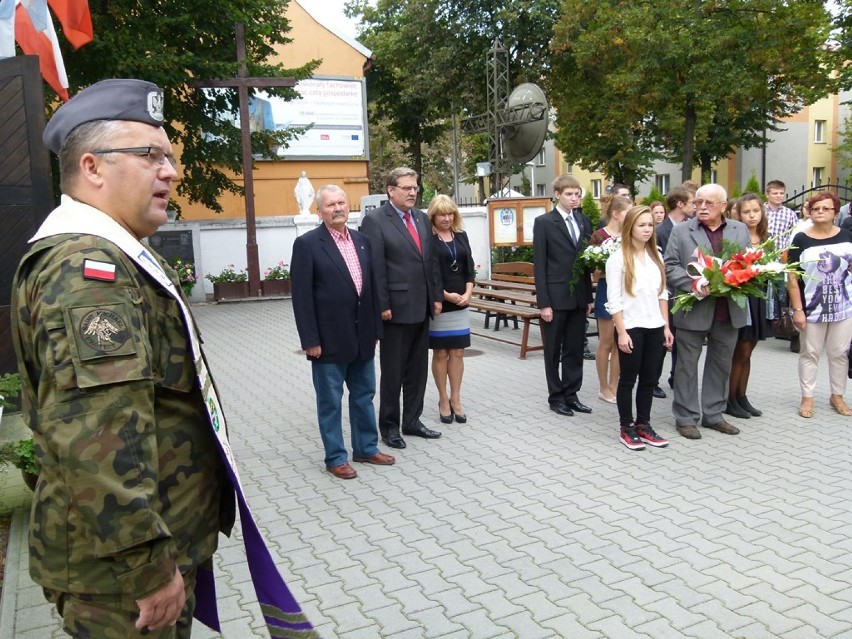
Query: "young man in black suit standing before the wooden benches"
533 175 592 416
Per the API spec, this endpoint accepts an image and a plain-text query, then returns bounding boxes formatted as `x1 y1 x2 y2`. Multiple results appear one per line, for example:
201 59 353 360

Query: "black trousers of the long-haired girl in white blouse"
615 326 666 426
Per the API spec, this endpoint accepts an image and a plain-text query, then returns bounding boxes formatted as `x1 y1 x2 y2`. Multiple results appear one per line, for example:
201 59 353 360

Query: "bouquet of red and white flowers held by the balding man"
672 238 798 311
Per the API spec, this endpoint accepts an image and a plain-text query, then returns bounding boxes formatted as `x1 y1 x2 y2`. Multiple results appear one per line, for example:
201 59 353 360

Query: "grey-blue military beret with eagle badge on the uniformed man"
42 79 163 155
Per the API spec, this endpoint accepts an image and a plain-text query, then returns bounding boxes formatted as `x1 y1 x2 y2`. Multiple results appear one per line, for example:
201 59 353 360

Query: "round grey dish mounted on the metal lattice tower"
501 82 548 164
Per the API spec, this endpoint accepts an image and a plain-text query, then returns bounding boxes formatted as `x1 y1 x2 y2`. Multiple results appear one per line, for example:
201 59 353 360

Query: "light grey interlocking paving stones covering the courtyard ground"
5 300 852 639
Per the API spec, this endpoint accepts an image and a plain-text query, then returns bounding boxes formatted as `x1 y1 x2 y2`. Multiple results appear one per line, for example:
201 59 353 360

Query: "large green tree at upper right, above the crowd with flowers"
548 0 839 184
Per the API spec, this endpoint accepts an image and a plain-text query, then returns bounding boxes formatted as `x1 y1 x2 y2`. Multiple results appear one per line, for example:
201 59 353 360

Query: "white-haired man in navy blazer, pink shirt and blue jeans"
291 184 395 479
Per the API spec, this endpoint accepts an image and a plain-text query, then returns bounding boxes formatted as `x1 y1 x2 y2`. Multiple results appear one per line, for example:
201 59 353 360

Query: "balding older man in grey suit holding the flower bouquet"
665 184 750 439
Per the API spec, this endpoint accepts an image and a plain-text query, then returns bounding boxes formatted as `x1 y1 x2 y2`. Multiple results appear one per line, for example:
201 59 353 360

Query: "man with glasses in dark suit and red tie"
361 167 443 448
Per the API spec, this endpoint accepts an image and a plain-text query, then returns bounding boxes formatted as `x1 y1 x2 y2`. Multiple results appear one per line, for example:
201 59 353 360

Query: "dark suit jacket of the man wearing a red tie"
361 202 443 324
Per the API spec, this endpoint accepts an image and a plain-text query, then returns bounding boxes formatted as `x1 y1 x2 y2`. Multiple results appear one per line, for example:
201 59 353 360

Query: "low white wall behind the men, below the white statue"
160 206 491 302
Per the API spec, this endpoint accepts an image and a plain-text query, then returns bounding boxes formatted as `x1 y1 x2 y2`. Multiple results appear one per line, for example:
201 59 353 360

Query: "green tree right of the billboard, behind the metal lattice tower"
347 0 558 195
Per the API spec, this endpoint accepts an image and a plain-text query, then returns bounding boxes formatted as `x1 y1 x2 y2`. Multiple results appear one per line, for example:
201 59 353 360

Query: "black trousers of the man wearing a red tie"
379 317 429 438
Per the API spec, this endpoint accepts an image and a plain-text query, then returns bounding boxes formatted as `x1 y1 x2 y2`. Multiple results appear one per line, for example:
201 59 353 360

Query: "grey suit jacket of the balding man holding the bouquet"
665 217 750 331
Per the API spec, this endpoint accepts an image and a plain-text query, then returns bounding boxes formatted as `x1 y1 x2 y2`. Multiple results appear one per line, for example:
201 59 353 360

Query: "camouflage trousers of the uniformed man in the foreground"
44 570 195 639
